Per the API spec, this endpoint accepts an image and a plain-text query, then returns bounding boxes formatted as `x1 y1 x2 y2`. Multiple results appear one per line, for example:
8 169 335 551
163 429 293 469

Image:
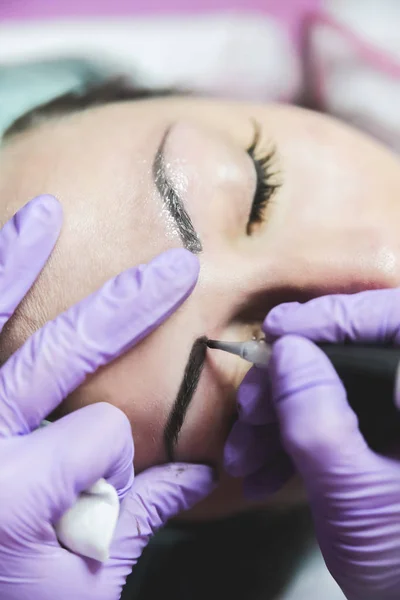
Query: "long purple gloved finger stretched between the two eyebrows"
0 249 199 436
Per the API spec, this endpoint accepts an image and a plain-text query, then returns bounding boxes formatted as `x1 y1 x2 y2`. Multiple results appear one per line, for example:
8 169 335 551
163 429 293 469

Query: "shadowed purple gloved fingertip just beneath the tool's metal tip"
237 367 276 425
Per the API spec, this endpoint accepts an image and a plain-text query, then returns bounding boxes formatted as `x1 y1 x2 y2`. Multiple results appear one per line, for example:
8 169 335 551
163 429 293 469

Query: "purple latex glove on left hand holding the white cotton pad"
0 197 213 600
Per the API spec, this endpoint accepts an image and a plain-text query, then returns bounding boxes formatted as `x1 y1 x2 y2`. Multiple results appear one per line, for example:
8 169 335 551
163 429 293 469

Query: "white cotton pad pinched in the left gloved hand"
55 479 119 562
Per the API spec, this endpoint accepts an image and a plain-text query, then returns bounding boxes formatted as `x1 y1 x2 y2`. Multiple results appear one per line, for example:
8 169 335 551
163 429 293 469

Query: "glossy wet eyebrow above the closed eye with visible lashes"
153 127 203 254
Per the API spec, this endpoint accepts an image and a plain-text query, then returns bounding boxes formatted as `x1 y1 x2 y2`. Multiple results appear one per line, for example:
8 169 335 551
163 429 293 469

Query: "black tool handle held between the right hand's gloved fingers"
318 344 400 452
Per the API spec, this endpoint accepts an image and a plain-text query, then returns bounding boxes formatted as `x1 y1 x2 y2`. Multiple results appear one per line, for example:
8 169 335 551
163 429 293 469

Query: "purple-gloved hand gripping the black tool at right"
227 289 400 600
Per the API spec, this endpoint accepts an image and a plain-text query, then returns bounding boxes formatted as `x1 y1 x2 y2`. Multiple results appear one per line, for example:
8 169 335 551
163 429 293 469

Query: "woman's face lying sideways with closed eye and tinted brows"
0 98 400 514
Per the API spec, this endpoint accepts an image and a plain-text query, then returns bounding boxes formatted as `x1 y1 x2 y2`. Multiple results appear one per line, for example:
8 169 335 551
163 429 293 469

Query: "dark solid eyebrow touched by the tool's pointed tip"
164 337 207 462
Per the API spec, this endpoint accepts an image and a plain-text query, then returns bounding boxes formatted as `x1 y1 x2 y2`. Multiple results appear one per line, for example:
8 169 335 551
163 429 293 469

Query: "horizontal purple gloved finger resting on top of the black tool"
263 289 400 344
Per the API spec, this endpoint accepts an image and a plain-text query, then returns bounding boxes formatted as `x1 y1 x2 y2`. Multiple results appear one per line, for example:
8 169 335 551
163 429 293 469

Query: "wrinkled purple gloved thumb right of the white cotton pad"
111 463 216 563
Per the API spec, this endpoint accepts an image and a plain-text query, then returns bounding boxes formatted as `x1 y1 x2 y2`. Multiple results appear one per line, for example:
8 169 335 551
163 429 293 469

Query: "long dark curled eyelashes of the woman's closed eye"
246 123 280 235
